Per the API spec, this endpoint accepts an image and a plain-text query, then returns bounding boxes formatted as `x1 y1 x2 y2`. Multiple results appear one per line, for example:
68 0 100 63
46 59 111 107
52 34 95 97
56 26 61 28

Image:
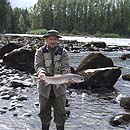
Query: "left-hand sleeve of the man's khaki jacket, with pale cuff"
34 48 45 74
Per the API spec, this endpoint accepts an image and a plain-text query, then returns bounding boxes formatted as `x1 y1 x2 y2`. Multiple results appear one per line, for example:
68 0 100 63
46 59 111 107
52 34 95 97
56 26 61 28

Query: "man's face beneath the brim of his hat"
46 36 59 48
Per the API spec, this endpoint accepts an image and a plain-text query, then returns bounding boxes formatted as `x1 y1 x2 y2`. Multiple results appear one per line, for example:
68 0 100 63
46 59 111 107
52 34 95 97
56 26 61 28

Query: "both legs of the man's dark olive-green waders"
39 90 66 130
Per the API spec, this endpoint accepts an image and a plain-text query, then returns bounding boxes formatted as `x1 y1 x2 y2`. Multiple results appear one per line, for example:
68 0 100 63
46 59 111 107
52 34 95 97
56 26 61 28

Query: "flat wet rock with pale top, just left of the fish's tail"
10 80 32 88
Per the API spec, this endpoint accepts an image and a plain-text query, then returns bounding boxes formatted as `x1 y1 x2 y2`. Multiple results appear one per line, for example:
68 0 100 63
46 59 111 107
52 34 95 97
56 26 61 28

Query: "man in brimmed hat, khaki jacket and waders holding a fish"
34 30 70 130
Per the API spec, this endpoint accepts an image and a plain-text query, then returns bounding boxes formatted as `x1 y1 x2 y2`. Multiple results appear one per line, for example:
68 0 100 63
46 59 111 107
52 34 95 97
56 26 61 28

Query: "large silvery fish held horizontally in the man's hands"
33 73 85 88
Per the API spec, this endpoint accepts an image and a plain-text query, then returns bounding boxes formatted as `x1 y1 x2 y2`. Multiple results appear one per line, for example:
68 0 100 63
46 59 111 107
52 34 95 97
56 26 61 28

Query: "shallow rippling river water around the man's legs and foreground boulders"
0 52 130 130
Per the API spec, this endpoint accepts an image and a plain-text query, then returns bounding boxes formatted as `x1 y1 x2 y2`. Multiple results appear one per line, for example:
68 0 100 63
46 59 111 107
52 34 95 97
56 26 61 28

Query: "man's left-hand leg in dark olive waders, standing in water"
38 95 52 130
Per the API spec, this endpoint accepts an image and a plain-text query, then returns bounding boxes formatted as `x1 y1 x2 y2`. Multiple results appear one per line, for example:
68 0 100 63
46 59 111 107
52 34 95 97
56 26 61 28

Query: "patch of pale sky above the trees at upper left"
9 0 38 8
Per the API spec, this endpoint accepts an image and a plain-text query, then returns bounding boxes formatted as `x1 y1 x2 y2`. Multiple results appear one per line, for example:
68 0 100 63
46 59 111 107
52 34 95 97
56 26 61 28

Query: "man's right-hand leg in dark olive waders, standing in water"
53 95 66 130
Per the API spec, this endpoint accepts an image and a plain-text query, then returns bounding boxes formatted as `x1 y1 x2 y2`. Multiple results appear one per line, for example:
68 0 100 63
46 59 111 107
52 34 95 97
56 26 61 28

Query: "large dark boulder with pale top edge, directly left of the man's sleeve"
3 47 36 73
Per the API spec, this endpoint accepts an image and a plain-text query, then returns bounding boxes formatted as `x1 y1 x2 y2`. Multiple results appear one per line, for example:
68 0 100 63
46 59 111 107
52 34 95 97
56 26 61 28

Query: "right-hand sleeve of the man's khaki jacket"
61 49 70 74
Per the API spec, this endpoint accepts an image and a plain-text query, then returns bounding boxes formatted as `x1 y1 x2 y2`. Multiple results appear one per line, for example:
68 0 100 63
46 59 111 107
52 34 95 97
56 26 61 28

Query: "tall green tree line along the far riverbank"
0 0 130 35
